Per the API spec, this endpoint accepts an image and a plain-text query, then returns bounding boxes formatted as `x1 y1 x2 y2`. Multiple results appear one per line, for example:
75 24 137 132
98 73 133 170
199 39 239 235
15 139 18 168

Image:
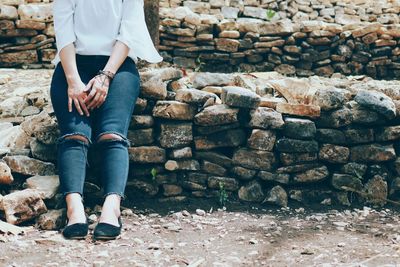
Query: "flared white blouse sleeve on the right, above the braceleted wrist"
116 0 163 63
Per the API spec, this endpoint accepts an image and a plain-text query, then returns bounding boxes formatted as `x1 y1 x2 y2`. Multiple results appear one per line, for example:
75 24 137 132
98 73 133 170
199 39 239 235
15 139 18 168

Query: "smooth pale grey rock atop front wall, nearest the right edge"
354 90 396 120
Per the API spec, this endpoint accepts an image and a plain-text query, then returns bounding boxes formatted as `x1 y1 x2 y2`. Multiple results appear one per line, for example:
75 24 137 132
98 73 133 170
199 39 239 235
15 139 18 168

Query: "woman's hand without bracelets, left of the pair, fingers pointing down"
68 79 90 117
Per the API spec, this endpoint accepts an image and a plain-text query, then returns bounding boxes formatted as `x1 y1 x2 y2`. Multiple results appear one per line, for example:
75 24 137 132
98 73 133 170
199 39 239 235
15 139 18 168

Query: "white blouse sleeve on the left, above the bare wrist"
53 0 76 52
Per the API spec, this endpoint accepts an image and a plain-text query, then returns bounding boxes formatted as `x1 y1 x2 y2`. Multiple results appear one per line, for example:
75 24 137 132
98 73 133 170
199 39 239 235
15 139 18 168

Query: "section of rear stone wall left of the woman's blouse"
0 0 56 68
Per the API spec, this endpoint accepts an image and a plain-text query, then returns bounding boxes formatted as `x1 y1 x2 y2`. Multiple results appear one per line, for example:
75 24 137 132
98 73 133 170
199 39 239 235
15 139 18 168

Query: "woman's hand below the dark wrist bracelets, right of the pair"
85 74 110 110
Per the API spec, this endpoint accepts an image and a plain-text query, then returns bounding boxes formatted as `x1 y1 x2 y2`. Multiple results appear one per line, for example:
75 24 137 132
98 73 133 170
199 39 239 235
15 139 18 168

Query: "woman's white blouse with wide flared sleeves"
52 0 163 65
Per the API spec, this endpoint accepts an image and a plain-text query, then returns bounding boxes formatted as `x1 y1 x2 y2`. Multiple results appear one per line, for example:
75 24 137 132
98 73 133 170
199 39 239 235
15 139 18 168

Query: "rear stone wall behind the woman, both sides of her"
0 0 400 79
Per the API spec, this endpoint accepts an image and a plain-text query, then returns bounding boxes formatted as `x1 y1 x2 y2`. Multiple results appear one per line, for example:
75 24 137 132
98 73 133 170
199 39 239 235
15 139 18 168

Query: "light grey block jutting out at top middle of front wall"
221 86 261 108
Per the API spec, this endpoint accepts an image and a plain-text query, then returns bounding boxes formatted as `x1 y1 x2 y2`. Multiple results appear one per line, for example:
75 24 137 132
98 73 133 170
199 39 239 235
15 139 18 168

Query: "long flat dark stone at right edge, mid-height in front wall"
350 144 396 163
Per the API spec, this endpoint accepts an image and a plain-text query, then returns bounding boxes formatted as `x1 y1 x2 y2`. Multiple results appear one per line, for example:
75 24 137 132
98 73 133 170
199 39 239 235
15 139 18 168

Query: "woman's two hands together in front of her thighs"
68 74 110 116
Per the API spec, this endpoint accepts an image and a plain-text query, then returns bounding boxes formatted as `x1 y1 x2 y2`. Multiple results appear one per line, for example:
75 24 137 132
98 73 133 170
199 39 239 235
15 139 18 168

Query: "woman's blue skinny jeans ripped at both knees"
50 55 140 198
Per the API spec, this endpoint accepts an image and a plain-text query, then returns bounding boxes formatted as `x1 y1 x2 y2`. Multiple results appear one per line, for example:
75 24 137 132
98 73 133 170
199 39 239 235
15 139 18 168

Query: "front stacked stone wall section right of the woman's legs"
108 69 400 206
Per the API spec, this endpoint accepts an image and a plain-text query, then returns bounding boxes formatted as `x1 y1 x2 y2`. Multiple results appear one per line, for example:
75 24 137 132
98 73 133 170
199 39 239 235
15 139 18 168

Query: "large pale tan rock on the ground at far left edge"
2 189 47 224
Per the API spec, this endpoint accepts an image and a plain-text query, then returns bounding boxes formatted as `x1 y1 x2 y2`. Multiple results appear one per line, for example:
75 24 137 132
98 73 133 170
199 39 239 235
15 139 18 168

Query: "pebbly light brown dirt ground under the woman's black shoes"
0 202 400 267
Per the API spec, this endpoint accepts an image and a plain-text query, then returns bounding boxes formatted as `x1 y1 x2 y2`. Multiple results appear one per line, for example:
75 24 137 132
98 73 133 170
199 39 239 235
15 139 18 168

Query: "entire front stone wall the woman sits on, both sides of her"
0 68 400 227
